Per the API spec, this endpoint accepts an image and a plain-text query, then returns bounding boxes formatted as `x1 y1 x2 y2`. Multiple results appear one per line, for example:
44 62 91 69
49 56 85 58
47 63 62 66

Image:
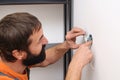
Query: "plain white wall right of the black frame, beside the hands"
73 0 120 80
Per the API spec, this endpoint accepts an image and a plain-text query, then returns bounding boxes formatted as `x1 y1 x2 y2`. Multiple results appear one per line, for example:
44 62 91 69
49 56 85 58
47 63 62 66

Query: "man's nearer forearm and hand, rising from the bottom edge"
65 42 93 80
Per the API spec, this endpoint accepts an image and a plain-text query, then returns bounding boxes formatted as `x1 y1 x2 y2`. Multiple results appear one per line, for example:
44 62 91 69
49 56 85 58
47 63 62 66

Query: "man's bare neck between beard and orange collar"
2 60 26 74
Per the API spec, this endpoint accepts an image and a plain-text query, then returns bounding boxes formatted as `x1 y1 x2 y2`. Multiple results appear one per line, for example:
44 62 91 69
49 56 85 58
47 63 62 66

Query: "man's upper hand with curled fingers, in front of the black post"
66 27 85 49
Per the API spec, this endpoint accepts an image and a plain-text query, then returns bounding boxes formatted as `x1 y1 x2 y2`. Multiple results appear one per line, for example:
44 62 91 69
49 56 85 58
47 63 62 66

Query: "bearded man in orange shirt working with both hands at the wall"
0 13 92 80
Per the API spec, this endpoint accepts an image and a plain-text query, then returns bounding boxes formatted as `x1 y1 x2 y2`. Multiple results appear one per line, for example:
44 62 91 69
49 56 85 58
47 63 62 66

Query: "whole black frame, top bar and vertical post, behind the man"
0 0 72 79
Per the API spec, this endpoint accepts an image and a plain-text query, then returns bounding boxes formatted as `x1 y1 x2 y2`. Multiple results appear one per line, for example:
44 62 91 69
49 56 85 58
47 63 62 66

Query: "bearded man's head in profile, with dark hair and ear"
0 13 47 66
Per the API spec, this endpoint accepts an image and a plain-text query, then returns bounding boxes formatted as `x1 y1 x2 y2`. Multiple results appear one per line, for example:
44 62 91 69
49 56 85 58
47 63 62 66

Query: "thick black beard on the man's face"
23 45 46 66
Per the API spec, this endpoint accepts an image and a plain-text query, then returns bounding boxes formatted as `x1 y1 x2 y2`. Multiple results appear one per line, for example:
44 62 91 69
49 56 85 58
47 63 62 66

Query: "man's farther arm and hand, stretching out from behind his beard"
33 27 85 67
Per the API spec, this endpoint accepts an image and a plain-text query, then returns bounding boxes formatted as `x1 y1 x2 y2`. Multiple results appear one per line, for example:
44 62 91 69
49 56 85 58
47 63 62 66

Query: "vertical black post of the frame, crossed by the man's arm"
64 0 72 78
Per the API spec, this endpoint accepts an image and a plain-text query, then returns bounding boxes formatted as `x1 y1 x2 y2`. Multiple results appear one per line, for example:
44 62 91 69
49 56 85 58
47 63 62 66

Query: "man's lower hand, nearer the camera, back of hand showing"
73 41 93 68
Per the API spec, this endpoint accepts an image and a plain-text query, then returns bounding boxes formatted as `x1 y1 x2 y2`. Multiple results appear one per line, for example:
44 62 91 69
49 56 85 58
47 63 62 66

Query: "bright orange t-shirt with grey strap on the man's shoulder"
0 61 28 80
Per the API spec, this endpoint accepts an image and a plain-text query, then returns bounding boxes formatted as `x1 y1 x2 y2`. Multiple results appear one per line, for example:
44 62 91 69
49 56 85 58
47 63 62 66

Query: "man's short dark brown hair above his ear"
0 12 41 62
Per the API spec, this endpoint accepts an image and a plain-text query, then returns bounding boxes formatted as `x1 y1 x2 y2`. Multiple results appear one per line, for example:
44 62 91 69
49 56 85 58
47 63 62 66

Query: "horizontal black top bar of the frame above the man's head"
0 0 66 4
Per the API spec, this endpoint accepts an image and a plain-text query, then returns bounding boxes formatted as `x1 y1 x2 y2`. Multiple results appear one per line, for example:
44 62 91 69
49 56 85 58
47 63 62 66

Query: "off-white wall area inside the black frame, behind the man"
0 4 64 80
